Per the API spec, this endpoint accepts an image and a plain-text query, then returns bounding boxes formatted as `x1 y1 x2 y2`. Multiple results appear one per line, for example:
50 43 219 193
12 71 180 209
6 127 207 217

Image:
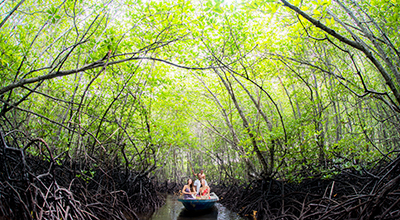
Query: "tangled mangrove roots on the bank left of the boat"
0 131 164 219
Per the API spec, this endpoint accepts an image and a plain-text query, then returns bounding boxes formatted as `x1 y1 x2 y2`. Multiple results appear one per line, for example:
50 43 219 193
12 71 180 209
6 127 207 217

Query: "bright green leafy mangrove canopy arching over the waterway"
0 0 400 182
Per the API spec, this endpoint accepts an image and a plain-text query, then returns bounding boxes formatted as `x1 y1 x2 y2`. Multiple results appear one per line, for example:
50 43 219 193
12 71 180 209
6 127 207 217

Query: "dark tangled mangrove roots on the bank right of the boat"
214 157 400 219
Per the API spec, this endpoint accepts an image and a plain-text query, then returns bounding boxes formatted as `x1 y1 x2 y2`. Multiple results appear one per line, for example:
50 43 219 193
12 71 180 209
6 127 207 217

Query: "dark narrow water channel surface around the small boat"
140 195 244 220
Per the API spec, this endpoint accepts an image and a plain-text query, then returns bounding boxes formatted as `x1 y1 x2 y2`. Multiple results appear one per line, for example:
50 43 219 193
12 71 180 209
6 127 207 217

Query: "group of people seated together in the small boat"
182 170 210 199
